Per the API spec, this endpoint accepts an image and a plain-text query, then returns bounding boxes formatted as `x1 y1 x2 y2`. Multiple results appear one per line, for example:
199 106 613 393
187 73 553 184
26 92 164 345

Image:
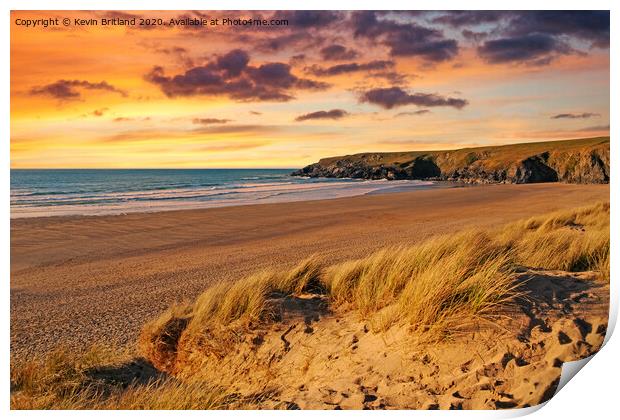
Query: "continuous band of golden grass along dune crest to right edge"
140 203 609 372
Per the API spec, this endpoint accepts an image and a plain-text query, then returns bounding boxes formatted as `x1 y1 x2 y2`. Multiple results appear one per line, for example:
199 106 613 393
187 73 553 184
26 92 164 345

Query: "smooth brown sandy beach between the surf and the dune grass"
11 183 609 357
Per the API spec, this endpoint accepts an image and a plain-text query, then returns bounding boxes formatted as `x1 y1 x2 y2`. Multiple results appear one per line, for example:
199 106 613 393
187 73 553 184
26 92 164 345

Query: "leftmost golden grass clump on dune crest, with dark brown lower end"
138 257 322 372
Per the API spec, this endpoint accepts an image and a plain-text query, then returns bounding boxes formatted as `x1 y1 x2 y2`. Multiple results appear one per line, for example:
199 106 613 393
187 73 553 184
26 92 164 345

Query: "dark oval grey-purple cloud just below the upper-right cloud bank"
478 34 573 65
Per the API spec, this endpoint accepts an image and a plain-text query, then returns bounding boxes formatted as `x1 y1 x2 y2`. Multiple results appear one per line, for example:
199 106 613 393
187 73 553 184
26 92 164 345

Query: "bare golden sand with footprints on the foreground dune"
149 271 609 409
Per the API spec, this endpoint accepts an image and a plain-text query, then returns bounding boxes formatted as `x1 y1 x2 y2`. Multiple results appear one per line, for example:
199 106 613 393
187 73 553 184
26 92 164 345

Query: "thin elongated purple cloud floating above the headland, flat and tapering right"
360 87 469 109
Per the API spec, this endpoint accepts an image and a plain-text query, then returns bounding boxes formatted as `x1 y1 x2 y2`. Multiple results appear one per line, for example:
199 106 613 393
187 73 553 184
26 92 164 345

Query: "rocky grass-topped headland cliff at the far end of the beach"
292 137 610 184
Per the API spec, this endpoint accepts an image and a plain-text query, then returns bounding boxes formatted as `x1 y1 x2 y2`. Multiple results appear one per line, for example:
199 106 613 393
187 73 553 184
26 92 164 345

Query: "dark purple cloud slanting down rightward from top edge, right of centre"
351 11 459 62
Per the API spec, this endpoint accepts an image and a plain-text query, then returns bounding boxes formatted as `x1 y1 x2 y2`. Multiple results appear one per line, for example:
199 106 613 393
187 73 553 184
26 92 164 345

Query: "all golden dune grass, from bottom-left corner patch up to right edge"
11 203 610 409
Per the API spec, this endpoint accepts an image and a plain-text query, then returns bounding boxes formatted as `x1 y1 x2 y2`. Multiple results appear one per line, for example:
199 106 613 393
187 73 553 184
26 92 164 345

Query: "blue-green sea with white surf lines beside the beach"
11 169 433 218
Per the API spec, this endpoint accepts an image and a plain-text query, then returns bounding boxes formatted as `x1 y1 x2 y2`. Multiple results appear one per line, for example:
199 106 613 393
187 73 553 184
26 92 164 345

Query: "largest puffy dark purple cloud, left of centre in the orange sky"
145 50 329 102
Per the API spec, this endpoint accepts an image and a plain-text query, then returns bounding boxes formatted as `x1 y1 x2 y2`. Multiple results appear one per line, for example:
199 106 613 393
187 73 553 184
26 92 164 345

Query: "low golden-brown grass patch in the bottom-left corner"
11 345 235 410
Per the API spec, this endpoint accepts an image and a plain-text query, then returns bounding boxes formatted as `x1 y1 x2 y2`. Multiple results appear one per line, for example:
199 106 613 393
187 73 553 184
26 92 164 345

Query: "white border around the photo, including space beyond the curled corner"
0 0 620 420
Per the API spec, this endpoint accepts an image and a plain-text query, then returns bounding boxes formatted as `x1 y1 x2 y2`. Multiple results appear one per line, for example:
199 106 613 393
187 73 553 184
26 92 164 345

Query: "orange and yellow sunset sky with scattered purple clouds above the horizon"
11 11 609 169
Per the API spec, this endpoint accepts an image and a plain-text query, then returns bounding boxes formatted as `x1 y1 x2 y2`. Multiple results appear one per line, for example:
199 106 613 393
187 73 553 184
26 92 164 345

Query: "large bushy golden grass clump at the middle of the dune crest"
325 231 516 338
